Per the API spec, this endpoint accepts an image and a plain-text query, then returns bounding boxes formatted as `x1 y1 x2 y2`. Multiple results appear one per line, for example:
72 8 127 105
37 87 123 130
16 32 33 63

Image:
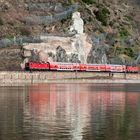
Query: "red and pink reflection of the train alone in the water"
29 84 132 116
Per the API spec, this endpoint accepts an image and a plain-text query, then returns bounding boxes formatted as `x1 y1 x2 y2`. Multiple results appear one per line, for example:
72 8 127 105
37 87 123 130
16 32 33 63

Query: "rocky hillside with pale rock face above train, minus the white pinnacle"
0 0 140 70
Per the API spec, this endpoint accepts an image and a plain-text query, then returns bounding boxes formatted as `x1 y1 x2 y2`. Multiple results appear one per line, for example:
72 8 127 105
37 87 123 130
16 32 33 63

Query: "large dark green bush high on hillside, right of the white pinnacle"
95 6 110 26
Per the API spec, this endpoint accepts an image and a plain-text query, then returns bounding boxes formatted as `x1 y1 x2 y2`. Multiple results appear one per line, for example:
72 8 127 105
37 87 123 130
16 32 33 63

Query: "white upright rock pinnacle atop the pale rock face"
70 12 84 34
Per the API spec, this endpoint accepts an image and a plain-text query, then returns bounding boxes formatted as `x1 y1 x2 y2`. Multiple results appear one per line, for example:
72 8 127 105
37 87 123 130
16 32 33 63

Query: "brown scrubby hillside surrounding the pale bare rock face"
0 0 140 70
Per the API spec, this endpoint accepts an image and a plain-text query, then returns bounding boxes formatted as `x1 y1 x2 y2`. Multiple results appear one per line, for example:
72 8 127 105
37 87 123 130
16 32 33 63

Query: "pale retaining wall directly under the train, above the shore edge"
0 72 140 85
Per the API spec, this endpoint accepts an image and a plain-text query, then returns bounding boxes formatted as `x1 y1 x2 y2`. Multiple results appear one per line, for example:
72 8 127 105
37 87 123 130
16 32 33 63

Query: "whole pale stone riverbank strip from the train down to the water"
0 71 140 86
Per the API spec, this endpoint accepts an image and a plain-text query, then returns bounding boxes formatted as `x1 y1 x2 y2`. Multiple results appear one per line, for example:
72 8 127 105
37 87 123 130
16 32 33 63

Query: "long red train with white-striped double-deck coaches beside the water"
25 62 139 73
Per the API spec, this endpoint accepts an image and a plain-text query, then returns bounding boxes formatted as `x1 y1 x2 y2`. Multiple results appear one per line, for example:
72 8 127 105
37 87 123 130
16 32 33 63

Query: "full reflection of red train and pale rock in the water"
27 84 139 139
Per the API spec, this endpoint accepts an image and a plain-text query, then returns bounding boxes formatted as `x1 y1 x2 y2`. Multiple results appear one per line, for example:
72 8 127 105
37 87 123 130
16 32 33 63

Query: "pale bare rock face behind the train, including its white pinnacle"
23 12 92 68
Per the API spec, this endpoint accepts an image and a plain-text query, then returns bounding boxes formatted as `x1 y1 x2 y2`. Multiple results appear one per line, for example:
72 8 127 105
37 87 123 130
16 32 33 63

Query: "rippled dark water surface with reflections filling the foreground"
0 84 140 140
